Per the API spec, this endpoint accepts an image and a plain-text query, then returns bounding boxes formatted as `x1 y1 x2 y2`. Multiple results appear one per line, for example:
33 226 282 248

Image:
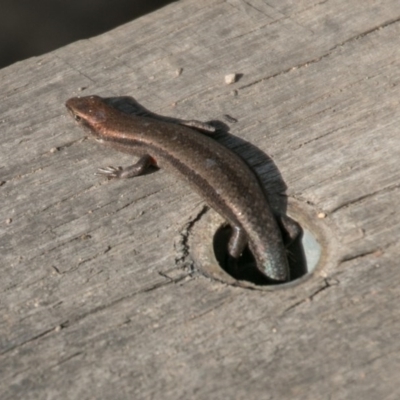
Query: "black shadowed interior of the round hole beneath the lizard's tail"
213 225 308 286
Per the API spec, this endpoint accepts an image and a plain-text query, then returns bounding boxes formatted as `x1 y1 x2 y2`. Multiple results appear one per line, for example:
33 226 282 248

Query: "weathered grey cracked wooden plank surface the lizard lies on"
0 0 400 399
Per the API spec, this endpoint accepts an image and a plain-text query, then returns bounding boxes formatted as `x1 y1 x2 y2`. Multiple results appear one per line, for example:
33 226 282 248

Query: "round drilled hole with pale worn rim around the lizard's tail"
187 199 324 291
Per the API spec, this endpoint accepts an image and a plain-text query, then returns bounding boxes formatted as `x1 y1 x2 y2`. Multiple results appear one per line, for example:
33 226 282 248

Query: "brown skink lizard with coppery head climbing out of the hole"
66 96 296 281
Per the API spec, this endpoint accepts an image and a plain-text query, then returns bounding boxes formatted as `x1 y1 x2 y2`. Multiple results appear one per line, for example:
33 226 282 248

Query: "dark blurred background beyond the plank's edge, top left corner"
0 0 173 68
